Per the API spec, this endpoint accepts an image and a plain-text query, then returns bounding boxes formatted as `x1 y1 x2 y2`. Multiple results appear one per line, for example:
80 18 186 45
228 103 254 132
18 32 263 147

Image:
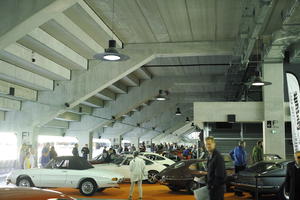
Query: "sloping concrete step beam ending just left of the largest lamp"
54 12 104 54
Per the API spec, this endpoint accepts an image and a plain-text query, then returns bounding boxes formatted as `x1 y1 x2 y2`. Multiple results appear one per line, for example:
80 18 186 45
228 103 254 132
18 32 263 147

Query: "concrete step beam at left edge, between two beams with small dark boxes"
0 60 53 90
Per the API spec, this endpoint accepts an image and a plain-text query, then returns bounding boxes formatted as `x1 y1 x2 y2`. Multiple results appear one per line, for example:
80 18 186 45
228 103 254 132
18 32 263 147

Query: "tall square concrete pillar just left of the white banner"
263 63 285 158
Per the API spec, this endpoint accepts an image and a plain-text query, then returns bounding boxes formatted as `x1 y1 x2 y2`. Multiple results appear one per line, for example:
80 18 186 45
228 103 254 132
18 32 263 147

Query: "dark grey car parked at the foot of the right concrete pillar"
232 160 290 200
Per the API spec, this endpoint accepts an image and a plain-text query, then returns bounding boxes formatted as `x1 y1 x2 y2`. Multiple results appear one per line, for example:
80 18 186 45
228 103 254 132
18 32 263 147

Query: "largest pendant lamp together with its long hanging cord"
94 0 129 62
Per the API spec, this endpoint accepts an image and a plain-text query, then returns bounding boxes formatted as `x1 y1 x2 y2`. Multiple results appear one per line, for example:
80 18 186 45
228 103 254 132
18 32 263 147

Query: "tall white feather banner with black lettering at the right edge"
286 73 300 152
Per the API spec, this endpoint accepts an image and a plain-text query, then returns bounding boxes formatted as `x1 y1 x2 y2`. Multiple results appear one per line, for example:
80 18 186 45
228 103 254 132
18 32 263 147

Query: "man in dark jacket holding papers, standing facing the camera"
199 136 226 200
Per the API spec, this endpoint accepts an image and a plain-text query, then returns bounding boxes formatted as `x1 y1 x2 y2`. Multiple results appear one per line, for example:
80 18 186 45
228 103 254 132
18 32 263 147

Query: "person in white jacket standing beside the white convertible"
128 151 146 200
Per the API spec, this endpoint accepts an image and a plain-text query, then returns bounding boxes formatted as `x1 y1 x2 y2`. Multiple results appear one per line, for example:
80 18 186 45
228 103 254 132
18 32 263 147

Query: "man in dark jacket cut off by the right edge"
285 151 300 200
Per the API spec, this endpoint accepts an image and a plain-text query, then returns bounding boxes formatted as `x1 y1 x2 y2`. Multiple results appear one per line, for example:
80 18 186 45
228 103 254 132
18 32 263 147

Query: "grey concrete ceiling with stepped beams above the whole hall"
0 0 299 144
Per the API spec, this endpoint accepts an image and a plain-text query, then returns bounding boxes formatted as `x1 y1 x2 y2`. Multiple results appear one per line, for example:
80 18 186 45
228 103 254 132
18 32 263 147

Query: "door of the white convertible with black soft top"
40 160 69 187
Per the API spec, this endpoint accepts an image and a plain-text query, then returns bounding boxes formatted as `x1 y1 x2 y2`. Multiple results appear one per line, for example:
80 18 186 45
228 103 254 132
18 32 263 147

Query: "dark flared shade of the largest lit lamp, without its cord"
94 40 129 61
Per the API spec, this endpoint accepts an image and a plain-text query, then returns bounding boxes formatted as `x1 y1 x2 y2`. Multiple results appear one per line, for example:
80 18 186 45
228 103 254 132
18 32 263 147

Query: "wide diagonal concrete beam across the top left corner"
0 0 76 49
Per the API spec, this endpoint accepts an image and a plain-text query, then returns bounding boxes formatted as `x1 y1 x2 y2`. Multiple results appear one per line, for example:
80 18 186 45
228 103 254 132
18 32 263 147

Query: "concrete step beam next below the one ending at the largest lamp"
18 28 87 70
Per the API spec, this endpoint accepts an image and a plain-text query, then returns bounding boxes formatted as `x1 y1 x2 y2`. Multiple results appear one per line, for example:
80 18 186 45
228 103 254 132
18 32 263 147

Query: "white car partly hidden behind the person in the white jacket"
93 155 166 184
